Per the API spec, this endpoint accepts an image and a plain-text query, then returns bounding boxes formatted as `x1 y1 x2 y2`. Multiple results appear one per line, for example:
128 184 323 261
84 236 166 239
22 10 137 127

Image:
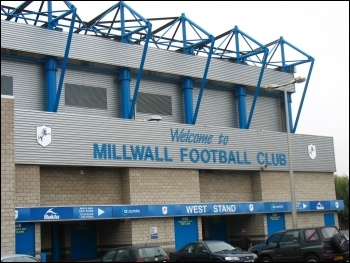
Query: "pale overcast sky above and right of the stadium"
1 1 349 175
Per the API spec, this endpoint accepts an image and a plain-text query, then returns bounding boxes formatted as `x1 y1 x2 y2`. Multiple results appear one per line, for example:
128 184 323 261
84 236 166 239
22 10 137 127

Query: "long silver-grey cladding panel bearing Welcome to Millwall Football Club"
15 110 335 172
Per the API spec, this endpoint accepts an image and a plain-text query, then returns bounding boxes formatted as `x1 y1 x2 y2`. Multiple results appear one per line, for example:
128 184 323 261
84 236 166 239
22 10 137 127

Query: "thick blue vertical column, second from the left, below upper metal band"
119 68 133 119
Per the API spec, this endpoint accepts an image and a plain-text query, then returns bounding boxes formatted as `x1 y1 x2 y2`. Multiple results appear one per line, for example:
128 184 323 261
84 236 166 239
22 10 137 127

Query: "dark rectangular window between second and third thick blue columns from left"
137 92 172 116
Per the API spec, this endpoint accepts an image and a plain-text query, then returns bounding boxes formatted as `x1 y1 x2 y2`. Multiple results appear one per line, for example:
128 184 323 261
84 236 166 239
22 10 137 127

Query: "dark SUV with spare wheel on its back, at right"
258 226 349 262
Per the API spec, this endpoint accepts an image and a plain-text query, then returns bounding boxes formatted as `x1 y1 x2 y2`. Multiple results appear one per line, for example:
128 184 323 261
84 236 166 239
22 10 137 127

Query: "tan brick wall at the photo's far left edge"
1 96 16 255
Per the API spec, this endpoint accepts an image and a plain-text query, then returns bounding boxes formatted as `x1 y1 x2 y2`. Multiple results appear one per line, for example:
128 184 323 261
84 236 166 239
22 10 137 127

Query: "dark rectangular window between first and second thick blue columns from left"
65 83 107 110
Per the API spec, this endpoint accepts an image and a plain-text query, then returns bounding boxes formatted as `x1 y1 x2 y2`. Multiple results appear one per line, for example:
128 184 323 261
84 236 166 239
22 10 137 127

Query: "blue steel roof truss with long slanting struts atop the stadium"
1 1 314 132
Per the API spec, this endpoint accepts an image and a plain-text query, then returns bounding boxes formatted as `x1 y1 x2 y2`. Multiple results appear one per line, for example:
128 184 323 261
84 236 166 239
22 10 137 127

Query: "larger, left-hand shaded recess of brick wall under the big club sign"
40 167 123 206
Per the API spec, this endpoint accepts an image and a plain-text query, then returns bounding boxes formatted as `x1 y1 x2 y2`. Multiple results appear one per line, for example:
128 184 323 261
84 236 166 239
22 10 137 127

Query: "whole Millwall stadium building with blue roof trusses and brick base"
1 1 344 261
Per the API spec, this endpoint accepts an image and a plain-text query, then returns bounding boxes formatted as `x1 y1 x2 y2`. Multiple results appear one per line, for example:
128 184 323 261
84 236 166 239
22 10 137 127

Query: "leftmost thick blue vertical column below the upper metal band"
45 57 57 112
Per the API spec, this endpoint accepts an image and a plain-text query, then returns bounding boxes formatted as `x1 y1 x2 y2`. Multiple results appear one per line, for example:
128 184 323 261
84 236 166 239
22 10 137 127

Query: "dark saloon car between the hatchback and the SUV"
169 240 257 262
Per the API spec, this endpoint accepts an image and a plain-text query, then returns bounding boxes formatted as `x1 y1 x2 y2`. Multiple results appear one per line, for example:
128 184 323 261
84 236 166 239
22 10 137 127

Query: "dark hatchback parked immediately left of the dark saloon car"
97 245 170 262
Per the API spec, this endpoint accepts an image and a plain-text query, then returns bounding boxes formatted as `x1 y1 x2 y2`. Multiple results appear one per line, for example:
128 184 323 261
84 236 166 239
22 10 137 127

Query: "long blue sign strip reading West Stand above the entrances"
15 200 344 222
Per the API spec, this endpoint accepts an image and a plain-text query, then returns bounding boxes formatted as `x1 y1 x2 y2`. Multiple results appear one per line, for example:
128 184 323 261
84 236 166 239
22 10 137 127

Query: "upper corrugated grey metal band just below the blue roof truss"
1 20 293 87
